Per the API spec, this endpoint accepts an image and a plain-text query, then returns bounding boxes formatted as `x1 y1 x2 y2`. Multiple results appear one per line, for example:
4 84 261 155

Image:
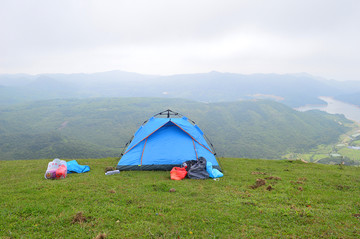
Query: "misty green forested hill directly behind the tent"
0 98 347 160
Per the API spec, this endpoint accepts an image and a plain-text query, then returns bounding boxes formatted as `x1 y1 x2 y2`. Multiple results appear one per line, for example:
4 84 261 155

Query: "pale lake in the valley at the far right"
296 96 360 122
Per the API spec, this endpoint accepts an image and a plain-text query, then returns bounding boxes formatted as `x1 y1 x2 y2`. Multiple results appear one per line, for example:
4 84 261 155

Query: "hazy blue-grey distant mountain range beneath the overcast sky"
0 71 360 107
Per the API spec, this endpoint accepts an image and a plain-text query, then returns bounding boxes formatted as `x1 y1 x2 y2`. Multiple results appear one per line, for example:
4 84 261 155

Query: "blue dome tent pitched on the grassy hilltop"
117 110 221 170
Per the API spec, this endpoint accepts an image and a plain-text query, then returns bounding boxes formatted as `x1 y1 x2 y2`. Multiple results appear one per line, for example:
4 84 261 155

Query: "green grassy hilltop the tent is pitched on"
0 158 360 238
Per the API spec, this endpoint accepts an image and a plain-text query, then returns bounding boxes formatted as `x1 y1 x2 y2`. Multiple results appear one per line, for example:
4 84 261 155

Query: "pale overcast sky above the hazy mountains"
0 0 360 80
